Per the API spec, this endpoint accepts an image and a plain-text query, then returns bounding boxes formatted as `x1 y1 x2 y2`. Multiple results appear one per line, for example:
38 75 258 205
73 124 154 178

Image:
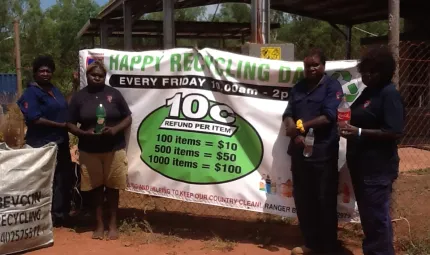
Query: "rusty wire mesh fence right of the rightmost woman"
399 41 430 170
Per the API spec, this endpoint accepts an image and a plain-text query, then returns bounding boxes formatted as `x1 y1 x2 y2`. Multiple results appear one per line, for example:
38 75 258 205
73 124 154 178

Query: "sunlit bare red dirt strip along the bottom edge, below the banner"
28 229 362 255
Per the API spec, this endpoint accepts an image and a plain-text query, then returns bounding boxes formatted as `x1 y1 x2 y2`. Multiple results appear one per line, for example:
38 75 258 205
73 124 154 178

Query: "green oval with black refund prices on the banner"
137 93 263 184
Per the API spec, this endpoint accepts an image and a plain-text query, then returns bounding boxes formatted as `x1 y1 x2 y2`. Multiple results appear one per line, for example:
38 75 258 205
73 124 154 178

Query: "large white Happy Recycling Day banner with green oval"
80 49 363 220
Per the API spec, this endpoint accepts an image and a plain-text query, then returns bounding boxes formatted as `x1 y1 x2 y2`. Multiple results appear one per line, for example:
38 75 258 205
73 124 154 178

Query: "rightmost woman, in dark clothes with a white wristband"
340 47 404 255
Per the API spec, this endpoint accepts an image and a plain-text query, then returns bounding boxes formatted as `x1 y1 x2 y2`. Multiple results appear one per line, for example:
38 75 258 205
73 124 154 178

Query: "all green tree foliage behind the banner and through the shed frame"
0 0 394 94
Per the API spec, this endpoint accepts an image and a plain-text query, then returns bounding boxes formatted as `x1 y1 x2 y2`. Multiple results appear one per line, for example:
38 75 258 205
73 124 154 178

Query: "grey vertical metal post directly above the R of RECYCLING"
163 0 176 49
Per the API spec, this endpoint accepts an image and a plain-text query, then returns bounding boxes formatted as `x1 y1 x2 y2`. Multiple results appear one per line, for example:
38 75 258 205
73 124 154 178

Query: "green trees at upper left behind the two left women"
0 0 99 94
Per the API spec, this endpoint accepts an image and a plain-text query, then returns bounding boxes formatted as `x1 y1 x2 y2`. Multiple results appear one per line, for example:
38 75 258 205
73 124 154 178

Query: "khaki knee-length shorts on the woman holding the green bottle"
79 149 128 191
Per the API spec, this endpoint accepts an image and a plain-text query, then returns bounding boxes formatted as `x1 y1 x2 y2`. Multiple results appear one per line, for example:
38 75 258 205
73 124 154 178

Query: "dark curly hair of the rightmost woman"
358 46 396 83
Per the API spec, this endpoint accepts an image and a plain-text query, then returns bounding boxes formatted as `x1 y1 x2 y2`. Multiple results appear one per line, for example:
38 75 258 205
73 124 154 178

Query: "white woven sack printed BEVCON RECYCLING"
0 143 57 254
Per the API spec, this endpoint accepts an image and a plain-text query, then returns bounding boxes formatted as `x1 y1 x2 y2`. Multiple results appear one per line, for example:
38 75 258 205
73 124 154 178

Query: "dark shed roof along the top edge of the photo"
98 0 428 25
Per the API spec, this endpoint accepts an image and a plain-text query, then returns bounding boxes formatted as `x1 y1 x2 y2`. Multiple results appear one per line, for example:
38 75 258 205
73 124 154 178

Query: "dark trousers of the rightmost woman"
348 162 396 255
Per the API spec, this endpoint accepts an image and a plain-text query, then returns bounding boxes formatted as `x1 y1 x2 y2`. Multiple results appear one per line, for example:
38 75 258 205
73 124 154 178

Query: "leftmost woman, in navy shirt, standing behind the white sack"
17 56 73 226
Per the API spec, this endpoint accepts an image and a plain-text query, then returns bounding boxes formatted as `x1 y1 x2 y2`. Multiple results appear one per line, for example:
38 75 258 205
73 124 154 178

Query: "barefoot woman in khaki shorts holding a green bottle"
68 61 132 240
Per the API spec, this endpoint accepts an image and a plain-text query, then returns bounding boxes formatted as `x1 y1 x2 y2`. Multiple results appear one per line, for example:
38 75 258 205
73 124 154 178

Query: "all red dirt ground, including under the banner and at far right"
28 145 430 255
